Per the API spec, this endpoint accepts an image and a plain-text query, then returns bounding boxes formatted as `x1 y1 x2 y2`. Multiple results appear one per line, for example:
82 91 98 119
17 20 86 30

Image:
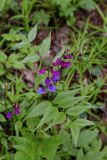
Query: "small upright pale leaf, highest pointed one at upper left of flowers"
28 24 37 42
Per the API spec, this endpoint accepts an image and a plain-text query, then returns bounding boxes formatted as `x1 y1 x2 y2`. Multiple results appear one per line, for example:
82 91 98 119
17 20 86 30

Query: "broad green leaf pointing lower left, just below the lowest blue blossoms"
26 101 51 119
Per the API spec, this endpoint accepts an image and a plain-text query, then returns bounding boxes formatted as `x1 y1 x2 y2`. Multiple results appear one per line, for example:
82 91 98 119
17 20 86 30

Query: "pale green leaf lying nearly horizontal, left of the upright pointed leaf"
22 55 39 63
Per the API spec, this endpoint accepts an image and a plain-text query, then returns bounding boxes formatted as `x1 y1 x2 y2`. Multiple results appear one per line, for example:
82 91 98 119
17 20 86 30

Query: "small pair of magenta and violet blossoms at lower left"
6 104 20 119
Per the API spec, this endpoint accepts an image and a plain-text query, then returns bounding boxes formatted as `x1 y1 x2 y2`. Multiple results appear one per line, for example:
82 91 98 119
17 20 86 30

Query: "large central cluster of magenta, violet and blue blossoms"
37 54 73 95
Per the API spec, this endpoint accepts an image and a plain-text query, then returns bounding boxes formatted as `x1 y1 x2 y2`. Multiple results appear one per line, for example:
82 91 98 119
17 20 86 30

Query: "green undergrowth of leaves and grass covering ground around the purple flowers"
0 0 107 160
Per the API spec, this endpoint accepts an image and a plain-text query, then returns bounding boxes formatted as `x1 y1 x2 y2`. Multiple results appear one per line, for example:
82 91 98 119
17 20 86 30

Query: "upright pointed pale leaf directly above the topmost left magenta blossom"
39 33 51 56
